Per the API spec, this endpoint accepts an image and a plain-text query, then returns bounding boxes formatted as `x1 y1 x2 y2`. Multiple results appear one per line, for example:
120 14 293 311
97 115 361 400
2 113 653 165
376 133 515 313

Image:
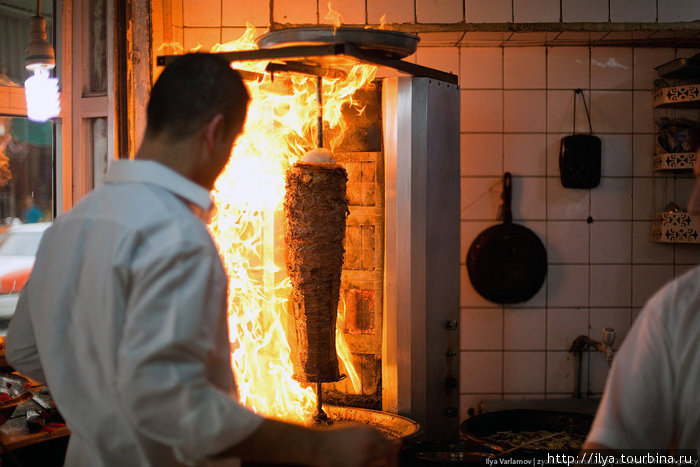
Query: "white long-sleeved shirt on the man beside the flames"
6 161 262 467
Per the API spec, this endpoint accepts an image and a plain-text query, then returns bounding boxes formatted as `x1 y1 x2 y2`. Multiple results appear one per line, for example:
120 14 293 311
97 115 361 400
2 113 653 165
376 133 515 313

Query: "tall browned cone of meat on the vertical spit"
284 150 348 394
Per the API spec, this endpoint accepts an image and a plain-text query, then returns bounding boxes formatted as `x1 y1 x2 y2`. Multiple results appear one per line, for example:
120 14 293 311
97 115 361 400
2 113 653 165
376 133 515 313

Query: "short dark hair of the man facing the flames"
146 53 250 141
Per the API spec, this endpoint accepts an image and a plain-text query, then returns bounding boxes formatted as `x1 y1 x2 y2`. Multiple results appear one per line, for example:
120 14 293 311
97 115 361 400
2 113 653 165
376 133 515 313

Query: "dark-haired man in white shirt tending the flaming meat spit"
6 54 396 467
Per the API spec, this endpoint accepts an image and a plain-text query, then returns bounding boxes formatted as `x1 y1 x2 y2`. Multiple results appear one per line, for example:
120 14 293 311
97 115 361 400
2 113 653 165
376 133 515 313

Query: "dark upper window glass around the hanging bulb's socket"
0 0 55 86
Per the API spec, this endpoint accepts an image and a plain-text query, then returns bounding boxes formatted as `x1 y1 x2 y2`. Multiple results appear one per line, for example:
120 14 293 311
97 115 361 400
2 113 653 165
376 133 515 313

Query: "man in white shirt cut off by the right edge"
583 158 700 455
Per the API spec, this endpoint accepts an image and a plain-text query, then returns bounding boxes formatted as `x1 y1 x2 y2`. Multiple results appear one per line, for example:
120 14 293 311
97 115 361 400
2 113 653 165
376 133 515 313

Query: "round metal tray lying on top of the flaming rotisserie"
255 27 420 59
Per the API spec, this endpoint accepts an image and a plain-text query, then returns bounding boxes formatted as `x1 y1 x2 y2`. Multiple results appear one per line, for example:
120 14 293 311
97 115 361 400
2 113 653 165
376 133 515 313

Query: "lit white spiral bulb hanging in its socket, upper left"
24 0 61 122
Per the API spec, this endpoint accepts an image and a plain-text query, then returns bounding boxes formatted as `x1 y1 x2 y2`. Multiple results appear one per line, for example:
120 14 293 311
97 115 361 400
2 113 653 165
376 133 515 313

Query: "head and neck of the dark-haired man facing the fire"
136 53 250 188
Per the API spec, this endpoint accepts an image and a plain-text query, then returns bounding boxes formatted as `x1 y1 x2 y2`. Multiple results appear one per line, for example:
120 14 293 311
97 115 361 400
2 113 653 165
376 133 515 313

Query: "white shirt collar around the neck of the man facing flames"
105 160 212 213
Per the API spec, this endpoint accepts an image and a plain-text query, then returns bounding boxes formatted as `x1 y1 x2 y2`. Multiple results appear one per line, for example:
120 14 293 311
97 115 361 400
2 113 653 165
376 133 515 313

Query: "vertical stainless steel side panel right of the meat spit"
382 78 459 440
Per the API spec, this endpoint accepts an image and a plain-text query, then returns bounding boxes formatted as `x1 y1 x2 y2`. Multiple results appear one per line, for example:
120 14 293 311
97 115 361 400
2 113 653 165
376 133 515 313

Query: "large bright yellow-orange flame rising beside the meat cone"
209 27 376 422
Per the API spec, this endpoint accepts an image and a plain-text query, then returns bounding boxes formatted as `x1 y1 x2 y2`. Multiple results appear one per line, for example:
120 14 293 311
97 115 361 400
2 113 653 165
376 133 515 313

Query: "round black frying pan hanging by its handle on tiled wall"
467 172 547 304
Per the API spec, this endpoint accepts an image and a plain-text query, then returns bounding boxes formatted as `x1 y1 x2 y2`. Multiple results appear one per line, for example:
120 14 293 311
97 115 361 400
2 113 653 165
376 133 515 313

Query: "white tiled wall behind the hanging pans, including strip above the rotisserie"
168 0 700 426
